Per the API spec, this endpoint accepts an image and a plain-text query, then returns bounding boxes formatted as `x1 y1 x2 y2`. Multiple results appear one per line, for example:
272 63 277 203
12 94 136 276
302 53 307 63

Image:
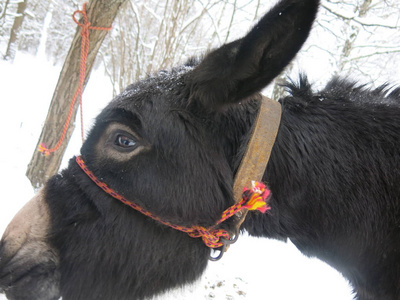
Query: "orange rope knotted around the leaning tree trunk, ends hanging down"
38 3 111 156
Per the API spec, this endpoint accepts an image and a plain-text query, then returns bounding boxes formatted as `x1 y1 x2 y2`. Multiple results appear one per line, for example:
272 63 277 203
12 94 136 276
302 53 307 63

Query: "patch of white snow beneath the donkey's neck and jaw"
155 236 353 300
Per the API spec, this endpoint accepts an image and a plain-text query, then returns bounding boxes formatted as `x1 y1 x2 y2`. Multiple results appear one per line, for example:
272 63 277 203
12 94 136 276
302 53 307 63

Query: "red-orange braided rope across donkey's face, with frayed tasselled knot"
76 156 271 248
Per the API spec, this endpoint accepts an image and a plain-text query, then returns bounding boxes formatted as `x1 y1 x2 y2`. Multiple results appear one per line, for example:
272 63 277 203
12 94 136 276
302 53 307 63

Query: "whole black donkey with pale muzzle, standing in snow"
0 0 400 300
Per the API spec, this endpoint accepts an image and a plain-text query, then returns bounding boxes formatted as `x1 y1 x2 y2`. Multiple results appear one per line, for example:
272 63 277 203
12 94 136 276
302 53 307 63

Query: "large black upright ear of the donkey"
190 0 319 109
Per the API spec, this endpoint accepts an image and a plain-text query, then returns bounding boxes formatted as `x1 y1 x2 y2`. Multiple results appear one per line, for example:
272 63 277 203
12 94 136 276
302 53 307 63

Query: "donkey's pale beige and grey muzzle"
0 189 60 300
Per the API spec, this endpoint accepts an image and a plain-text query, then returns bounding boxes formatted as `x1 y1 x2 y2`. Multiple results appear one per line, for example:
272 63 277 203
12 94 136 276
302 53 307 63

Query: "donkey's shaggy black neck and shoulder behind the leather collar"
245 77 400 300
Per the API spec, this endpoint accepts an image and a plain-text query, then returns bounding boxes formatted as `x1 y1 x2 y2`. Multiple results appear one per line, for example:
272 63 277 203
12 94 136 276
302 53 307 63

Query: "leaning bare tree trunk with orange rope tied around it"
26 0 125 188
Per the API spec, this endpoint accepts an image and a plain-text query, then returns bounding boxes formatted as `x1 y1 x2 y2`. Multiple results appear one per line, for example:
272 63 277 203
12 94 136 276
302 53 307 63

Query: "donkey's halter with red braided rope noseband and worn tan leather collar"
76 97 280 260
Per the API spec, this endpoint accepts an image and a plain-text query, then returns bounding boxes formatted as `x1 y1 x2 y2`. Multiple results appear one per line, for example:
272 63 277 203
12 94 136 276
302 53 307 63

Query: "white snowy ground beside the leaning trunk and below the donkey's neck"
0 54 353 300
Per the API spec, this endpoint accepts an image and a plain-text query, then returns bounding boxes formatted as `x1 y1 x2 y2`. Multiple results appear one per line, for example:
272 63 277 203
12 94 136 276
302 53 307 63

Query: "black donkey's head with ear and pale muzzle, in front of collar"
0 0 319 300
